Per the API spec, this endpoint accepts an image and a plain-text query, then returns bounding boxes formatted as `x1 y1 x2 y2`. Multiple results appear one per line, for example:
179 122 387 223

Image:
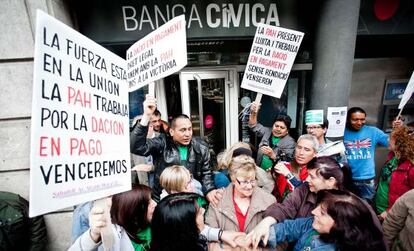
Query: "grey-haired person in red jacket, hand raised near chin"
273 134 319 201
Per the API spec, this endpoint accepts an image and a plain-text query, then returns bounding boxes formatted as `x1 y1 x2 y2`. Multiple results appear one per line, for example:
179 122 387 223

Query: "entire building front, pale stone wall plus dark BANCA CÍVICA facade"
0 0 414 250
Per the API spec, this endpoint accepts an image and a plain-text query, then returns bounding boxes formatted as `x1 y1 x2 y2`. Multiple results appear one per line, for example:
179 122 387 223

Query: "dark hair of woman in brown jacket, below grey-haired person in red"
307 156 352 190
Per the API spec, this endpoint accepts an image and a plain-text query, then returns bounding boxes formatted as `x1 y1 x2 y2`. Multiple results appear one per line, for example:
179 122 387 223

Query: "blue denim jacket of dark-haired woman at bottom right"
267 217 336 251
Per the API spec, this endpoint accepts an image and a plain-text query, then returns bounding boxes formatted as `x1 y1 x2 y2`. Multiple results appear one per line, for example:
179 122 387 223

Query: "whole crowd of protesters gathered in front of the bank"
70 95 414 251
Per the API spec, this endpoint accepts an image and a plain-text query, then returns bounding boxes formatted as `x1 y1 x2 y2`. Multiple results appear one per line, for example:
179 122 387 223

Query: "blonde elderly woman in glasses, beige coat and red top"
206 155 276 249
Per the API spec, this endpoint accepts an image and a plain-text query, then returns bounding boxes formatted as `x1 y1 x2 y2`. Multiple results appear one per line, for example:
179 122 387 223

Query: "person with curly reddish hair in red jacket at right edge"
375 126 414 220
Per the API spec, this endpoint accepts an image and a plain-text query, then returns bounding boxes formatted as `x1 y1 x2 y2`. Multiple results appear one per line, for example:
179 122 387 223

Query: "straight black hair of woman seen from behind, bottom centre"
151 193 207 251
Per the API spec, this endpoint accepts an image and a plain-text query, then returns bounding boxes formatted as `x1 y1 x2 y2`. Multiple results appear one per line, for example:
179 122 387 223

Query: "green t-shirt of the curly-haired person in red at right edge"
375 156 398 214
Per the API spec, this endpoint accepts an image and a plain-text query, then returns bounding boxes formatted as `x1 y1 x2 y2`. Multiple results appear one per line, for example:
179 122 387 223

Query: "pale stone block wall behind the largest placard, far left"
0 0 73 250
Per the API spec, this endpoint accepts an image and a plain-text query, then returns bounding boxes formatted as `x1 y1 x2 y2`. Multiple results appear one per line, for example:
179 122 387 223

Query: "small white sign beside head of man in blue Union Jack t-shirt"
326 106 347 137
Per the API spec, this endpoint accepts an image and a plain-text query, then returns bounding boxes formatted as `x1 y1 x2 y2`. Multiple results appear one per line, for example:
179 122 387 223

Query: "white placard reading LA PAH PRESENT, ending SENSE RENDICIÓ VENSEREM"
241 24 304 98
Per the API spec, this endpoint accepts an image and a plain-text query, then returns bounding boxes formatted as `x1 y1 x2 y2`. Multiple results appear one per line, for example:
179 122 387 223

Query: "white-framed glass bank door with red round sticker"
180 70 238 157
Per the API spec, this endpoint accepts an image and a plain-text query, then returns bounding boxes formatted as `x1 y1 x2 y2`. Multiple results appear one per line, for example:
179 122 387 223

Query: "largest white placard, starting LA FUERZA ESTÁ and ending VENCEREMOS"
29 11 131 217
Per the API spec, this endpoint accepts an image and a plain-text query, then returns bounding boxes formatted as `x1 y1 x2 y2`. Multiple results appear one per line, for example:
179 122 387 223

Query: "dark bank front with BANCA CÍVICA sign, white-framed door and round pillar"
69 0 414 152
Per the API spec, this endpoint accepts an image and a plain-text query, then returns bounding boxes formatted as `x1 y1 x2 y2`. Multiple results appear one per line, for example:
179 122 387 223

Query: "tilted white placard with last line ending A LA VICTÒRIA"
127 15 187 92
